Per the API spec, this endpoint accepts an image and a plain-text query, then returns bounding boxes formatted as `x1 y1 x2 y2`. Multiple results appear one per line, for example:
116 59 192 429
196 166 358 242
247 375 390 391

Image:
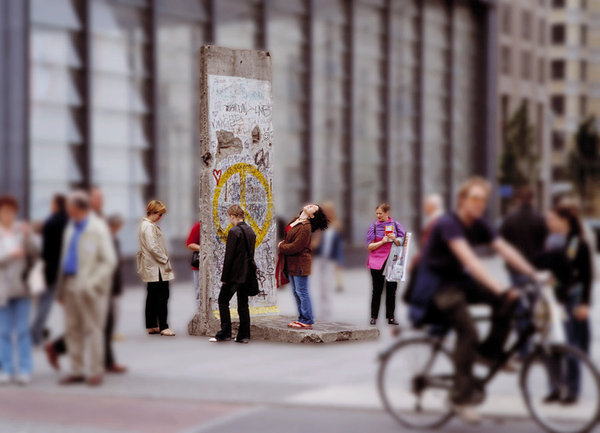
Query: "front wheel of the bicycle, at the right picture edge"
521 344 600 433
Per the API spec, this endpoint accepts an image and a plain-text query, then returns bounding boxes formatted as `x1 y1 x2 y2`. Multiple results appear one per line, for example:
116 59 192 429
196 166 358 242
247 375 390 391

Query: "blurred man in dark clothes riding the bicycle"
410 177 536 422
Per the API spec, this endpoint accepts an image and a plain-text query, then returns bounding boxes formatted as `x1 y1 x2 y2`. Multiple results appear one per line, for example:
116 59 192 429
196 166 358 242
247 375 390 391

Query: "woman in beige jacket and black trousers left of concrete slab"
137 200 175 337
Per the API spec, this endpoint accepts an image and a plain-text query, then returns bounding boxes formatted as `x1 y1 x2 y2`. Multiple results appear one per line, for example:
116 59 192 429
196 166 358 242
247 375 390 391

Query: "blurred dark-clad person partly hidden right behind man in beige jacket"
104 214 127 374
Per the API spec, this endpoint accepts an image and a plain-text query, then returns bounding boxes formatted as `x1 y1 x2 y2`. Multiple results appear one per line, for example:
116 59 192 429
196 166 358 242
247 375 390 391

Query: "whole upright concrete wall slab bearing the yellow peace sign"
188 46 278 335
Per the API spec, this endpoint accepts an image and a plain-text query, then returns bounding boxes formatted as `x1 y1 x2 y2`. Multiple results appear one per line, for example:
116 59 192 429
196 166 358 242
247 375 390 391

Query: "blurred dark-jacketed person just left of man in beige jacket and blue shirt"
31 194 69 346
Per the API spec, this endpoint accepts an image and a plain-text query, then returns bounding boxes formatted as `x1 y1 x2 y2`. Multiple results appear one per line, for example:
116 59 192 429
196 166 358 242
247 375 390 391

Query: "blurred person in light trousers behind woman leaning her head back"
311 201 344 320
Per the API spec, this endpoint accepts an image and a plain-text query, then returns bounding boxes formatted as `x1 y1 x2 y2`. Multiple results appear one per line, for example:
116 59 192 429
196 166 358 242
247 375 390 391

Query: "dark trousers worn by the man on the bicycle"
433 277 516 404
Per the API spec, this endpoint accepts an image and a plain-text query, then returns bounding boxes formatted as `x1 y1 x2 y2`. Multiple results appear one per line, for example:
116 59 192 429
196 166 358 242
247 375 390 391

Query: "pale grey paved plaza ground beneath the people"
0 255 600 433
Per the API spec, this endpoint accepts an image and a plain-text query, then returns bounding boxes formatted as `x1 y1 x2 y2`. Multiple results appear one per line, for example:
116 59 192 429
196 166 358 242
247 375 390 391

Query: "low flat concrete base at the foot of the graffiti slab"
189 316 379 344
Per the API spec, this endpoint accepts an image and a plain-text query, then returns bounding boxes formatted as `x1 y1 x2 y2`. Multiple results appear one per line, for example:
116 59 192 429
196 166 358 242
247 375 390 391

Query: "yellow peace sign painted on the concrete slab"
213 162 273 247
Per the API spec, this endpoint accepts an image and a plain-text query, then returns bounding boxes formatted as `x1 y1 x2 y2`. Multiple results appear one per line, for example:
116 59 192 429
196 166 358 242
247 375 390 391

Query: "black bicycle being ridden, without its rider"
377 283 600 433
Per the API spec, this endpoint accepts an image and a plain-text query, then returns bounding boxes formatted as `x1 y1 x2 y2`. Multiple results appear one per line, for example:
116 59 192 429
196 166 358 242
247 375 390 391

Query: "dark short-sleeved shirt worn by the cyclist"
410 212 498 322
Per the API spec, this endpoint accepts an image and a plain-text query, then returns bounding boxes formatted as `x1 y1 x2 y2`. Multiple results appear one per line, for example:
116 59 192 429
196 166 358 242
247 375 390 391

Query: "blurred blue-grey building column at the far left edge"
0 0 29 217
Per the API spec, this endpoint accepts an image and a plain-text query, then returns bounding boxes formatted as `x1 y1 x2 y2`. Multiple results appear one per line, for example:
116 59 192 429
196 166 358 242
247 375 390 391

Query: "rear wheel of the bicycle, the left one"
378 338 454 428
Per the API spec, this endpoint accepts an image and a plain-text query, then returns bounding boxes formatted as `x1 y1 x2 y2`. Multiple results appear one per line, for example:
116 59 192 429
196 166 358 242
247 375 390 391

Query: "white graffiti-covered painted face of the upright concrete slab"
202 75 276 313
